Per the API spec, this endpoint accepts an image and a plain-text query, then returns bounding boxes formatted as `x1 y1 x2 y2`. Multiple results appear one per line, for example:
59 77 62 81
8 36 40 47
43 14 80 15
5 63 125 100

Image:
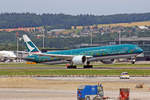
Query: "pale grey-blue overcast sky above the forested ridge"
0 0 150 15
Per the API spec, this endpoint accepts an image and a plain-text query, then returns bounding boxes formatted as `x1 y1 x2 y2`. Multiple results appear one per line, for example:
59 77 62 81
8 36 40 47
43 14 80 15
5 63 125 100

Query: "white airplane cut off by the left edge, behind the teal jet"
0 50 17 62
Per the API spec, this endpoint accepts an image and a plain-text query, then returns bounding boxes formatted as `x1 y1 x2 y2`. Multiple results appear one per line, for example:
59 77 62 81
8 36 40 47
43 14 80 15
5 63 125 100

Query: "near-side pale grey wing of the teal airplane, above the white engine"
37 53 93 60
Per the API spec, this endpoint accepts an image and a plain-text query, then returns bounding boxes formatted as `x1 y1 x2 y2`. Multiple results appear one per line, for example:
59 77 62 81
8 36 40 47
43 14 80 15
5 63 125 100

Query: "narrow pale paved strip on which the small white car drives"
34 77 150 84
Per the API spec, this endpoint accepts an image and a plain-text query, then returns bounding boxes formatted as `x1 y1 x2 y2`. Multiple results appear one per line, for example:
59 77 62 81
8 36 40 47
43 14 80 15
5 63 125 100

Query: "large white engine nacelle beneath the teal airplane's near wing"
72 56 87 65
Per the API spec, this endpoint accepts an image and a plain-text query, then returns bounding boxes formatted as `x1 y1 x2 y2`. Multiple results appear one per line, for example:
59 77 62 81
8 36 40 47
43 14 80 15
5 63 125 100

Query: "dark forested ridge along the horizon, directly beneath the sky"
0 13 150 28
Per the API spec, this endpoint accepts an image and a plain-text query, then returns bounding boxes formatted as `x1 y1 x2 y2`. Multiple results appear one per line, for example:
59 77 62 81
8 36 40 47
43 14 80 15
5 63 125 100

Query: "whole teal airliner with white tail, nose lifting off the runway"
23 34 143 68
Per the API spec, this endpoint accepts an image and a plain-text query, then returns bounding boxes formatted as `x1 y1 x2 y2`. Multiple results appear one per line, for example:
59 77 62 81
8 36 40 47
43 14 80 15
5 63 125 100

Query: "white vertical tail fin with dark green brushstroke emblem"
23 34 41 53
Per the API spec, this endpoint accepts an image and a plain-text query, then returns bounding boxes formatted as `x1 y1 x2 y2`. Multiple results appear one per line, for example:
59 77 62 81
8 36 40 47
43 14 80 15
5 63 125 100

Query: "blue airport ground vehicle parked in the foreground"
77 84 104 100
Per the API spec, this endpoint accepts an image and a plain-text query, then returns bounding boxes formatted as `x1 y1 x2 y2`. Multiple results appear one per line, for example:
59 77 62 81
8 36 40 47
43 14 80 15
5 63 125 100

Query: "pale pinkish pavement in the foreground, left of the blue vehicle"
0 88 76 100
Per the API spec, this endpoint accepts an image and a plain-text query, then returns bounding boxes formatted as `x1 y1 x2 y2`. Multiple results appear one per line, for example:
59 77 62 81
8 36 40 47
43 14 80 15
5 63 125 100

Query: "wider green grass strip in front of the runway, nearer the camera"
0 69 150 76
